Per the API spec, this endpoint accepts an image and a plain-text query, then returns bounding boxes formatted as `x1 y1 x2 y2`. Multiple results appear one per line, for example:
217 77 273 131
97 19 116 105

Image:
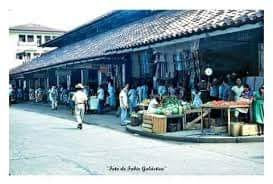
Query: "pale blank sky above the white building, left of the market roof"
8 3 111 31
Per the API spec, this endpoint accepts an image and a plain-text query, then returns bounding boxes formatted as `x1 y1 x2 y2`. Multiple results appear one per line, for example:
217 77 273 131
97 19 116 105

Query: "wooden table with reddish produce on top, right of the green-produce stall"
201 104 251 135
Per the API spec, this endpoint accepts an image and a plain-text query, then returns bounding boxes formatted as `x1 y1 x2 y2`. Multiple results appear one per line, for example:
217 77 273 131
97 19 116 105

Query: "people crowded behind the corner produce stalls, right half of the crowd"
116 73 264 134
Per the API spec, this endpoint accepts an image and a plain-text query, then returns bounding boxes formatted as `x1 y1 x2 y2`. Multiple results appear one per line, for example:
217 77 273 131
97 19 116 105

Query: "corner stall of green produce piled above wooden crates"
131 96 205 133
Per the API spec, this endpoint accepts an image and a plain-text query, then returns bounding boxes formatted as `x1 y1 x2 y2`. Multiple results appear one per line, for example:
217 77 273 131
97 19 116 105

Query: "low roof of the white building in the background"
9 24 65 32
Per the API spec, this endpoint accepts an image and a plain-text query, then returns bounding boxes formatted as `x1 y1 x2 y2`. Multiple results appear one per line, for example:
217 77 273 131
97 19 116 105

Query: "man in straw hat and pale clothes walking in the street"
72 84 87 129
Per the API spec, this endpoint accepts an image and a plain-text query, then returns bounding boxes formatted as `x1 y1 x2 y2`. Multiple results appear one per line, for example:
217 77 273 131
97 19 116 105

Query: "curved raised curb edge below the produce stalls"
126 125 264 143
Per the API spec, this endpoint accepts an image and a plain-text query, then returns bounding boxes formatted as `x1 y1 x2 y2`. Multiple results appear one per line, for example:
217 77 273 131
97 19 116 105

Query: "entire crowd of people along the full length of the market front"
8 74 264 132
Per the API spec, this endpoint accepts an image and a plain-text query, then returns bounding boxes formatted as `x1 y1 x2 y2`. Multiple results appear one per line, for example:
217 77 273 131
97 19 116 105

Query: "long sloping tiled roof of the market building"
10 10 263 74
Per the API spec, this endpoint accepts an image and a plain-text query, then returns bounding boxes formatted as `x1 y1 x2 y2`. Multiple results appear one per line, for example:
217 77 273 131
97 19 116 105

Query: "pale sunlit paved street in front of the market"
10 104 264 175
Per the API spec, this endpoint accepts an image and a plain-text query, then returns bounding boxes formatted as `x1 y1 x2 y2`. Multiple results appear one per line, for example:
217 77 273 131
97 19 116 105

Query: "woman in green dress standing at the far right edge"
253 85 264 135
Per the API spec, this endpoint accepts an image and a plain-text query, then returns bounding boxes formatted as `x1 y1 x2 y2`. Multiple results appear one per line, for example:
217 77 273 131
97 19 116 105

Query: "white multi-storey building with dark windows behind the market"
9 24 65 68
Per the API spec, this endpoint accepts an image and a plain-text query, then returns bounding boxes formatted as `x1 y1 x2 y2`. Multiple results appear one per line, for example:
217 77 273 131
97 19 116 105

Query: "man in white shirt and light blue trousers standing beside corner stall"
119 84 129 126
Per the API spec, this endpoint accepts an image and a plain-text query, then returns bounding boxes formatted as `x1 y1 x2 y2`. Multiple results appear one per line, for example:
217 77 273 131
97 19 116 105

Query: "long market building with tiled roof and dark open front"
10 10 264 94
